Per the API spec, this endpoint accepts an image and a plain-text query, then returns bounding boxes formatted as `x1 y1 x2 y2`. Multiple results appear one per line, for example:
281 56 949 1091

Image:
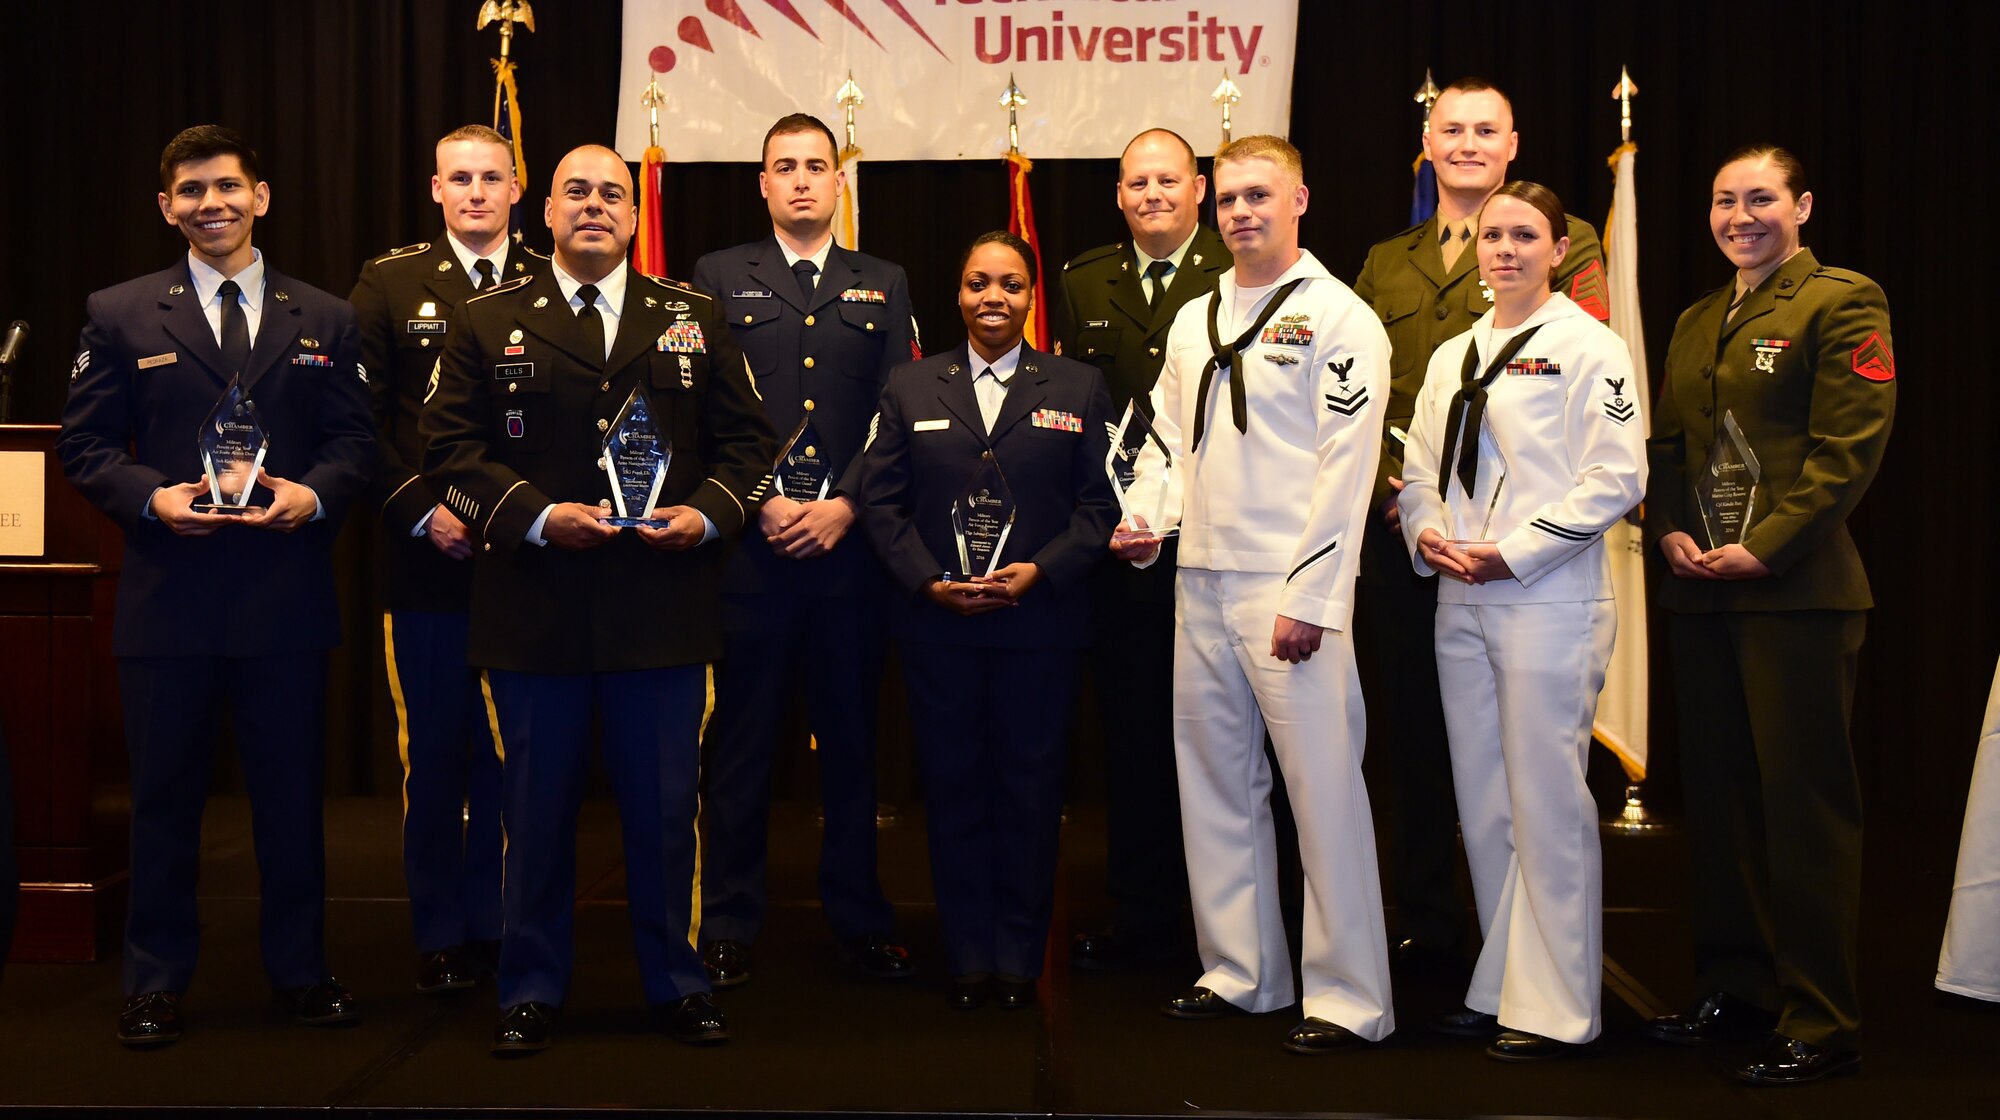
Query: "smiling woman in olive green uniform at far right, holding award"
1646 148 1896 1084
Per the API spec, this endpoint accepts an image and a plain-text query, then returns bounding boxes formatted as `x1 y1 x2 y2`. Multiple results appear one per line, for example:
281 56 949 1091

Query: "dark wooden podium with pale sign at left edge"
0 424 130 962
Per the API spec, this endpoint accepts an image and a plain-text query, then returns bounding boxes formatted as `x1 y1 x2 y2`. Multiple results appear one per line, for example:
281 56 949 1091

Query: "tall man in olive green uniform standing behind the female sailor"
1354 78 1610 964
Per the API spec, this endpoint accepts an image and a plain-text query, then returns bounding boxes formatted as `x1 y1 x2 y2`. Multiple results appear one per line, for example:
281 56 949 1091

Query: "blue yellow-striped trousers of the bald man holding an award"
486 666 708 1008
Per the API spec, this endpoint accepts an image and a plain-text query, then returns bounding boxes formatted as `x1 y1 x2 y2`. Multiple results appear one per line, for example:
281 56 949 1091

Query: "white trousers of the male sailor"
1174 568 1396 1042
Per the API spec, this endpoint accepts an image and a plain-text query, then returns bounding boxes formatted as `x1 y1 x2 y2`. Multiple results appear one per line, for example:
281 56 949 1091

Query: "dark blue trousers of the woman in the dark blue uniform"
904 642 1082 978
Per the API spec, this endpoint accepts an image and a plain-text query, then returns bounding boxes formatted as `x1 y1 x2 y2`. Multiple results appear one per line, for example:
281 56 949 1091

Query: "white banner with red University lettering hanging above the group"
618 0 1298 162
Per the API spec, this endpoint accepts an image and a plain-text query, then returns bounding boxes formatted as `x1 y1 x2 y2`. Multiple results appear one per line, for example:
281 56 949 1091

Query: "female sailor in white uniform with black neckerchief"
1400 182 1646 1062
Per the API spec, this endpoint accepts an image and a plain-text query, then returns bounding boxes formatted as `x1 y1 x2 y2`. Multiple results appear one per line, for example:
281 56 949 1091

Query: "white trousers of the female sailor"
1438 600 1618 1042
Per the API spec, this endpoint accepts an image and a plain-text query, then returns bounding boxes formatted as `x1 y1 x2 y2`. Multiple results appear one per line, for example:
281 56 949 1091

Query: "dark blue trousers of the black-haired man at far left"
118 650 328 996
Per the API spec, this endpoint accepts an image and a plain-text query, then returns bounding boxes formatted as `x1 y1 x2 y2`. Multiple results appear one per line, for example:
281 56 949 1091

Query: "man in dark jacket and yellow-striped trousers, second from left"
348 124 548 994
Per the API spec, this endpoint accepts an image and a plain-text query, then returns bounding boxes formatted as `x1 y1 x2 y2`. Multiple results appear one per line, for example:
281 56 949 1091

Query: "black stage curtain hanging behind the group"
0 0 2000 840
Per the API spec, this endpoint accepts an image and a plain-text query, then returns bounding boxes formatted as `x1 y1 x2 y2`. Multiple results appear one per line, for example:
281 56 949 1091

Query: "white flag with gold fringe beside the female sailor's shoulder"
1590 140 1652 782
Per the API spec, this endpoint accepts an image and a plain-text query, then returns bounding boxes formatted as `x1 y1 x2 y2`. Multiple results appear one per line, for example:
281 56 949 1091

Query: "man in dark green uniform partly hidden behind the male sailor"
1058 128 1230 968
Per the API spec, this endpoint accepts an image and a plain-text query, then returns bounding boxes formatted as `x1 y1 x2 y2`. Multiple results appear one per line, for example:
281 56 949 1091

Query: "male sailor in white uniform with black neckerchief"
1112 136 1394 1054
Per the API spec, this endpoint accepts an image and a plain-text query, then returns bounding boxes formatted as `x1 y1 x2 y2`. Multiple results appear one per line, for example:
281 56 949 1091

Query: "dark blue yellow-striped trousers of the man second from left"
382 610 500 952
